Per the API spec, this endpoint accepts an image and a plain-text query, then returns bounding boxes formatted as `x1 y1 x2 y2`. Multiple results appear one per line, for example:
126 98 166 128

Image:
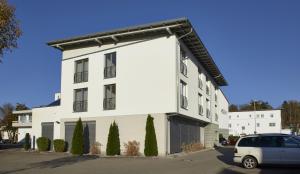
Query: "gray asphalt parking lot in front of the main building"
0 148 300 174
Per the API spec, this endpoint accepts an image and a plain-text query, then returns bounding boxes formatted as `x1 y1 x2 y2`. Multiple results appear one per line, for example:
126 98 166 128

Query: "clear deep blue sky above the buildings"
0 0 300 107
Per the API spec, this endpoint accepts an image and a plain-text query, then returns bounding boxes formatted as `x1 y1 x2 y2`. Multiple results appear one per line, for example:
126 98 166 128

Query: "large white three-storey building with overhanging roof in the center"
17 18 228 155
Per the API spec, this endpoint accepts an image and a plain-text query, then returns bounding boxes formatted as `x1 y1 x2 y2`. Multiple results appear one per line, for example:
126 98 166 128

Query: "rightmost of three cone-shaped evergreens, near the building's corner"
144 114 158 156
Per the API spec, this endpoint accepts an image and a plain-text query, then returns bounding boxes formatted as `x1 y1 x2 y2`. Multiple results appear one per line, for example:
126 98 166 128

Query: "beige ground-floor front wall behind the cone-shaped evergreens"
61 114 167 156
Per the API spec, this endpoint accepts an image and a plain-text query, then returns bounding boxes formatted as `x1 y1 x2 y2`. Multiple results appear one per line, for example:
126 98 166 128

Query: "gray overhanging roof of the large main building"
47 18 227 86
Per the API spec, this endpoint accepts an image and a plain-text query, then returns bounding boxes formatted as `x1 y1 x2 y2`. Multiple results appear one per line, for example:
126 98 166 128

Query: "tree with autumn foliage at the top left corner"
0 0 22 62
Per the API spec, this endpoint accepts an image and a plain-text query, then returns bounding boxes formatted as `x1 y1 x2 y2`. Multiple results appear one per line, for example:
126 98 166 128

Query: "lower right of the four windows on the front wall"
103 84 116 110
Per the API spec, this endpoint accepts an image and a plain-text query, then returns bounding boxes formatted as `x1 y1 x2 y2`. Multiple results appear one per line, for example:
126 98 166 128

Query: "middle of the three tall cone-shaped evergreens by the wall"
106 121 121 156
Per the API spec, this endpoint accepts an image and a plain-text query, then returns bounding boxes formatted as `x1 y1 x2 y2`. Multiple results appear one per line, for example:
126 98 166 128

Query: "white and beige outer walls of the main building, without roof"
28 18 228 155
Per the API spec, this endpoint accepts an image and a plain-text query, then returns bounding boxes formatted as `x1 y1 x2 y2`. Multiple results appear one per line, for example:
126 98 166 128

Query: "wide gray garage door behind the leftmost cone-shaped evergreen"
65 121 96 153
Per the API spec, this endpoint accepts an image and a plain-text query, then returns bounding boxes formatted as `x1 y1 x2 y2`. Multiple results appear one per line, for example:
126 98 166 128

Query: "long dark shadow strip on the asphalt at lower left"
0 155 99 174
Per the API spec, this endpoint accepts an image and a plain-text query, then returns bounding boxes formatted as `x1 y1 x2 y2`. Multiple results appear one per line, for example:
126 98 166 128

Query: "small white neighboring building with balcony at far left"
12 110 32 142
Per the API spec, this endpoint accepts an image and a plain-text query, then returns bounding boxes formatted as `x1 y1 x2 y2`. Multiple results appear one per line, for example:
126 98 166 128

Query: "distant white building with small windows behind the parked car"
228 110 281 136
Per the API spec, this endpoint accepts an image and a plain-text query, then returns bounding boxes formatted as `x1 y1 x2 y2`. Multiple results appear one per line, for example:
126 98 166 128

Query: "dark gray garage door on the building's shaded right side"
170 116 200 153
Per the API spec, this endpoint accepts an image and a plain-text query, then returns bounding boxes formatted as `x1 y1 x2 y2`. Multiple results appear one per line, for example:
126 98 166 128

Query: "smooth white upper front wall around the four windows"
61 36 176 118
